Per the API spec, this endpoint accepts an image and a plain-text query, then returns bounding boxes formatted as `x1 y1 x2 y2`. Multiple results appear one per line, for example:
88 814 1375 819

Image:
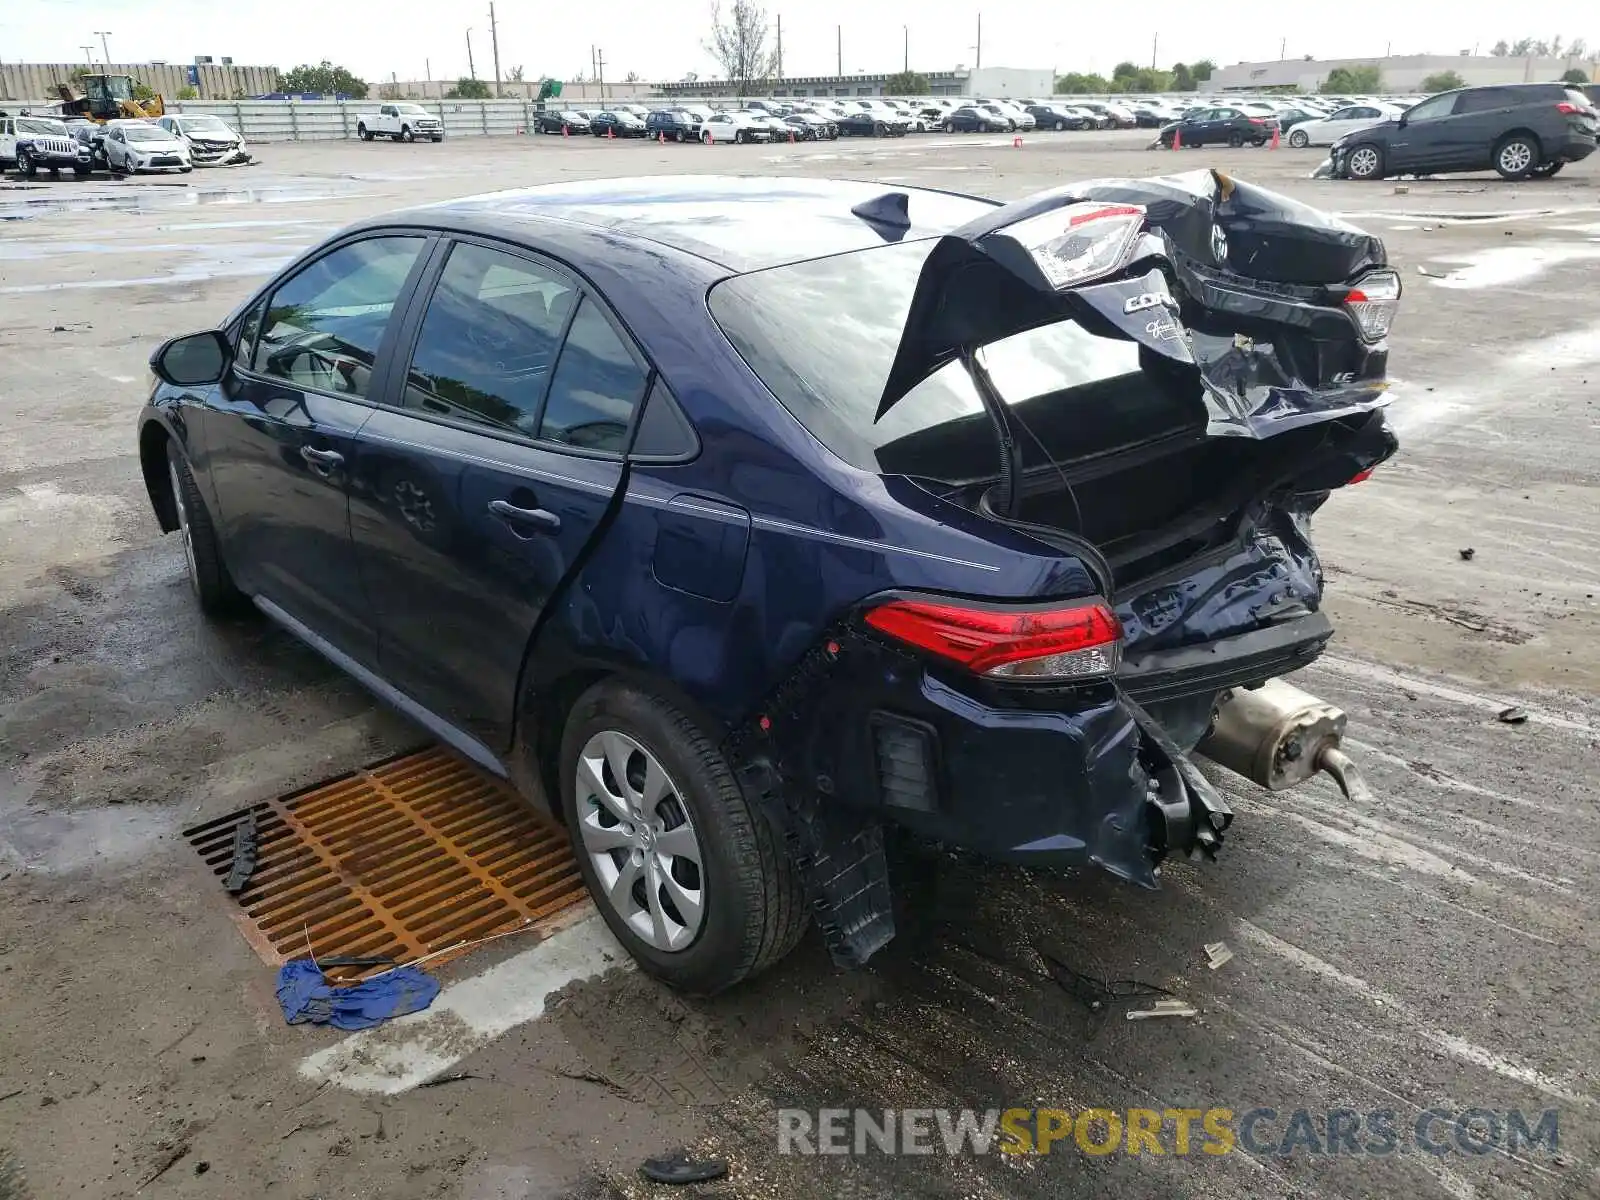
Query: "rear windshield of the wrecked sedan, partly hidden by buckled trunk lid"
710 240 1154 480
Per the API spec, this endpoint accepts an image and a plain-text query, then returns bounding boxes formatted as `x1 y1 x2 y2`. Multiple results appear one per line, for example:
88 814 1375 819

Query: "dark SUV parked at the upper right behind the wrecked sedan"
1324 83 1595 179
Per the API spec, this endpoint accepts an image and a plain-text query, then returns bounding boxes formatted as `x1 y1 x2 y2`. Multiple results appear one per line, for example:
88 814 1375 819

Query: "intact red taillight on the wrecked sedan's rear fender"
866 600 1122 680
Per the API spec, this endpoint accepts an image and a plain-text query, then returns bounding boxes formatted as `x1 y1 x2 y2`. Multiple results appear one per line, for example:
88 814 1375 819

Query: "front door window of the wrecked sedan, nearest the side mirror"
253 237 424 397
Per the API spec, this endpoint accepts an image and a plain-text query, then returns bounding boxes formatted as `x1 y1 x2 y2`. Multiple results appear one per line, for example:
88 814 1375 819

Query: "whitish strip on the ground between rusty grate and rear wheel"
299 906 630 1096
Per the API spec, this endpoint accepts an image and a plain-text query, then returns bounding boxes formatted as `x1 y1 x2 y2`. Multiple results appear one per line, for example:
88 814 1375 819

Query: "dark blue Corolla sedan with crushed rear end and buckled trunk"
139 173 1398 992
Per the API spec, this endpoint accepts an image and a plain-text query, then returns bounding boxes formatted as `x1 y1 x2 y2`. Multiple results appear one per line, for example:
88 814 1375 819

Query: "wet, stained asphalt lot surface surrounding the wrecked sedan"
0 134 1600 1200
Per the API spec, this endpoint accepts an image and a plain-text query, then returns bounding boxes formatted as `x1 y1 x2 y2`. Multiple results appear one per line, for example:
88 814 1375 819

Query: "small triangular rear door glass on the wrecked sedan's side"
539 296 645 454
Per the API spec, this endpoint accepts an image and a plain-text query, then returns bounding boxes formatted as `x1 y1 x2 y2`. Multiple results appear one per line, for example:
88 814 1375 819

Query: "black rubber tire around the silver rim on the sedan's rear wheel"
560 682 810 995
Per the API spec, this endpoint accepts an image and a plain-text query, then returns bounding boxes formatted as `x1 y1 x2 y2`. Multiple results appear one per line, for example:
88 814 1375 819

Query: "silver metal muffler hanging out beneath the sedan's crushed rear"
1195 678 1365 800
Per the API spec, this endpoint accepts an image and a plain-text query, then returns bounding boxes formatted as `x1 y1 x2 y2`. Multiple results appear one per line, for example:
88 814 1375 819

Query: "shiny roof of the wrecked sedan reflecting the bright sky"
400 176 997 272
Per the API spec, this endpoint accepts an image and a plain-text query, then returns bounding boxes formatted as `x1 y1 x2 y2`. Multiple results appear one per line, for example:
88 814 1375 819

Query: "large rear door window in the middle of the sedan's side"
405 242 578 437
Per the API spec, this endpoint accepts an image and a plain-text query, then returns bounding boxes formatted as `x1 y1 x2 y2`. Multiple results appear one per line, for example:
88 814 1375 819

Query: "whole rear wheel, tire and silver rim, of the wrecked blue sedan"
560 682 808 994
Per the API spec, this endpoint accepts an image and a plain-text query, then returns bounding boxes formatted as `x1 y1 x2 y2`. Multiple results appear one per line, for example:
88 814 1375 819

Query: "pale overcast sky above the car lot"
0 0 1600 80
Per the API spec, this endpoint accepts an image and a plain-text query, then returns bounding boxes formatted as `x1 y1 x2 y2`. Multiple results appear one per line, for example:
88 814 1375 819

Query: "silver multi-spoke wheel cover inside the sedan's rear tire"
578 730 706 952
